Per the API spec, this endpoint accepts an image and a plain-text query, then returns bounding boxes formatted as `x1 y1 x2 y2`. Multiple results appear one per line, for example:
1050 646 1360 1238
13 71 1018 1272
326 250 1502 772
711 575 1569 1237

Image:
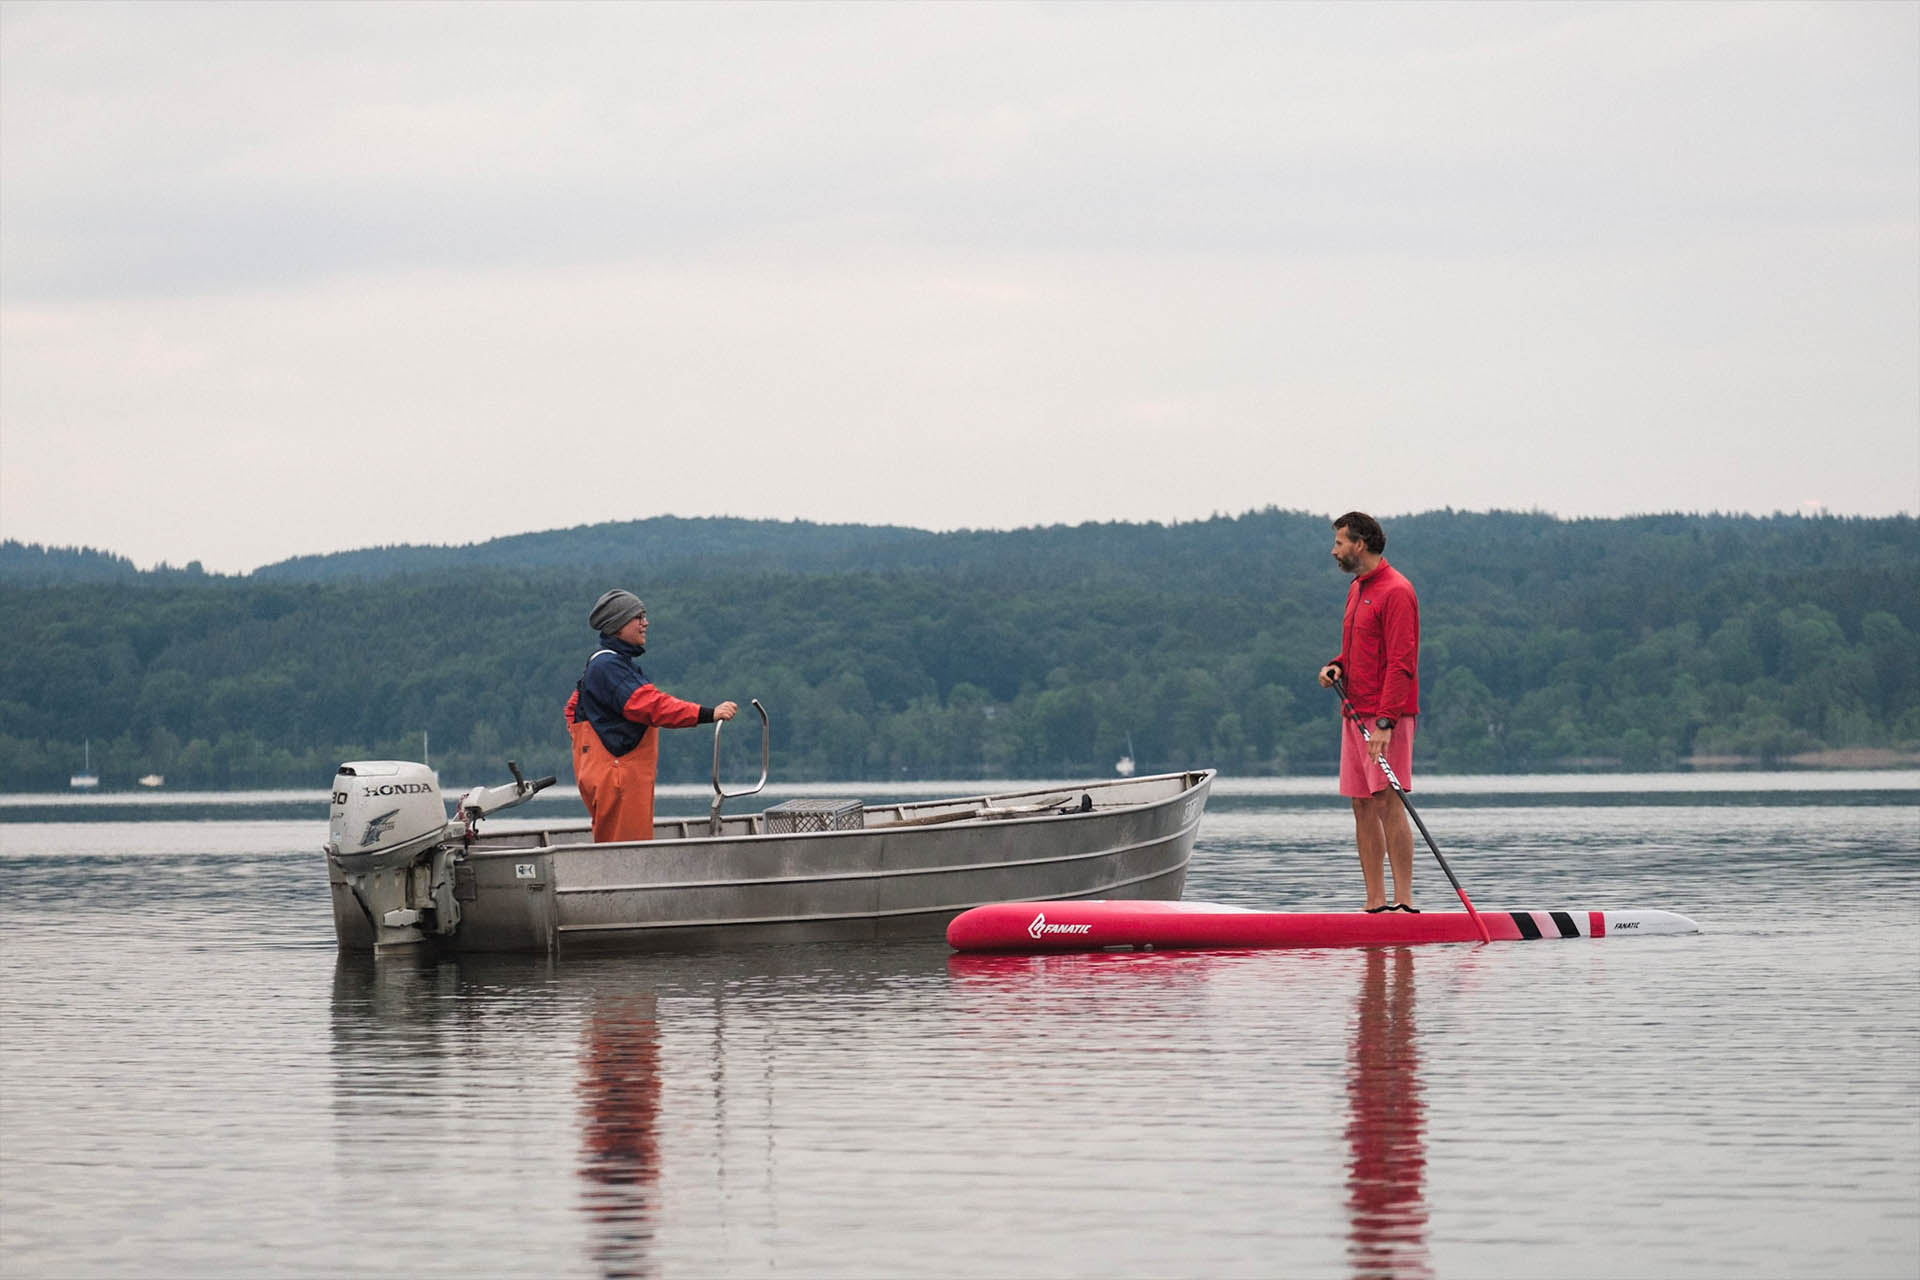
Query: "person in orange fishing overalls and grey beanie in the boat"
566 589 739 842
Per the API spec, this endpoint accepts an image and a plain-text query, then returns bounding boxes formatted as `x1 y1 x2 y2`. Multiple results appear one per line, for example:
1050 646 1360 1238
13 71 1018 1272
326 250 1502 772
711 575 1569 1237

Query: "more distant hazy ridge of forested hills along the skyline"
0 509 1916 593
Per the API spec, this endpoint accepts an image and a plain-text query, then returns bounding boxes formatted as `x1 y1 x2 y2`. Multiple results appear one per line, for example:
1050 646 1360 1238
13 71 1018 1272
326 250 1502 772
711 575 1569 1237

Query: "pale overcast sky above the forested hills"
0 2 1920 572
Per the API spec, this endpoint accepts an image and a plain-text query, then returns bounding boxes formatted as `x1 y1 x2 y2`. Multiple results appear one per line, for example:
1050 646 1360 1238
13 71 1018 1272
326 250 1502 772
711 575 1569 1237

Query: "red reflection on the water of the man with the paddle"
1346 946 1432 1280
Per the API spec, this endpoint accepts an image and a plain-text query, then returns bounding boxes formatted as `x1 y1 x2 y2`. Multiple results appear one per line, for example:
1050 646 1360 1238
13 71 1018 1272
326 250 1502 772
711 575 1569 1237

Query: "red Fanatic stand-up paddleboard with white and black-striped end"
947 900 1699 952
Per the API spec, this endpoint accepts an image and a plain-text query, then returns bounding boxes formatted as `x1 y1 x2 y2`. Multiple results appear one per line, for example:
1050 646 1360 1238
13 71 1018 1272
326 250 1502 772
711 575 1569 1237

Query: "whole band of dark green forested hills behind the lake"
0 510 1920 789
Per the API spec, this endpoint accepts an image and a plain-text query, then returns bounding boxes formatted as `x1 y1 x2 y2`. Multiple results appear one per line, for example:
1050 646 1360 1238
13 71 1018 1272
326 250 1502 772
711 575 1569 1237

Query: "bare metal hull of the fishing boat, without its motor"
328 771 1213 952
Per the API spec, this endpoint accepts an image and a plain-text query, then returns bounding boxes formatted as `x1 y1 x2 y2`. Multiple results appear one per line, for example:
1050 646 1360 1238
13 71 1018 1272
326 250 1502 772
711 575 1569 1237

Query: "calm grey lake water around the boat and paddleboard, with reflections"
0 771 1920 1280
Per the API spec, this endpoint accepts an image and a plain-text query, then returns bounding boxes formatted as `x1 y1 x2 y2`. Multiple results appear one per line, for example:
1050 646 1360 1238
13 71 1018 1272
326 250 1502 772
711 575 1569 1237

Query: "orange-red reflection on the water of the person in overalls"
580 994 660 1276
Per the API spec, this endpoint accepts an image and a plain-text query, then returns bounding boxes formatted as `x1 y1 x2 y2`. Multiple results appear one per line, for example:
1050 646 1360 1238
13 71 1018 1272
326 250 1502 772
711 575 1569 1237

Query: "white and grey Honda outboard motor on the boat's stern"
326 760 555 948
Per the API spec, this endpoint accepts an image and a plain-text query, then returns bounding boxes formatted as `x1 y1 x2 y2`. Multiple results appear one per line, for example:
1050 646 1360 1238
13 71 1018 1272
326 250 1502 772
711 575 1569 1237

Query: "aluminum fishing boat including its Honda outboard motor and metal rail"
326 702 1213 952
